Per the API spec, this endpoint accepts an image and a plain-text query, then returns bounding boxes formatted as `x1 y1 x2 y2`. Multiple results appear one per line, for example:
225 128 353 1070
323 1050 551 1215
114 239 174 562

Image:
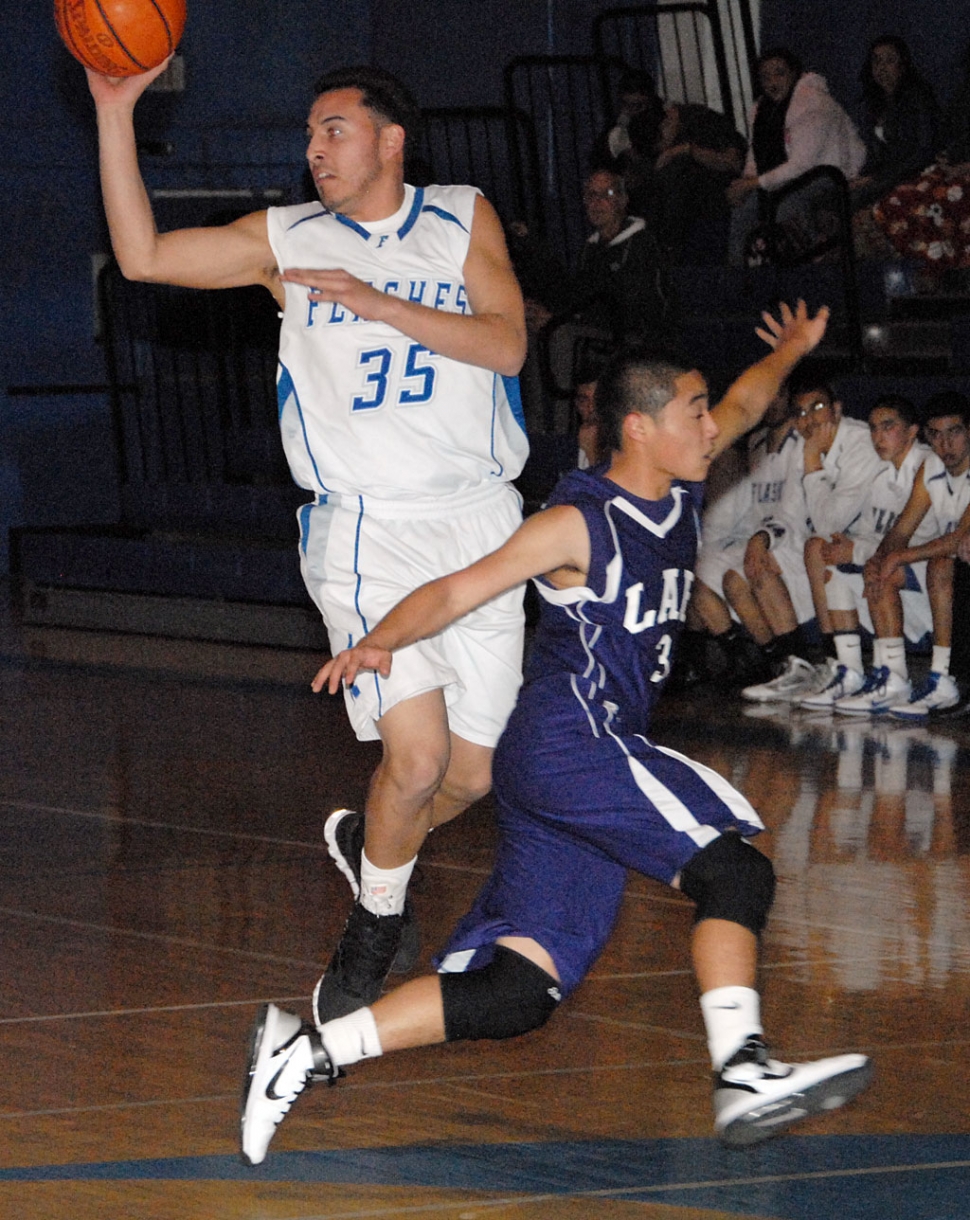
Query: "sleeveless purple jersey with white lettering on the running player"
523 467 704 733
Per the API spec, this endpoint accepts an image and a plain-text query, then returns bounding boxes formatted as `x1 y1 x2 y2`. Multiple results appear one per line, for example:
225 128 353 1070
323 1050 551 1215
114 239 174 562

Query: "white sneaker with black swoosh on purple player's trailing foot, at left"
239 1004 340 1165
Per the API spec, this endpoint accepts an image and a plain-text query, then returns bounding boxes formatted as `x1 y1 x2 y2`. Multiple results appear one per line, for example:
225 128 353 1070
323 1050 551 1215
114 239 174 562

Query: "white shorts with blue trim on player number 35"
298 484 523 747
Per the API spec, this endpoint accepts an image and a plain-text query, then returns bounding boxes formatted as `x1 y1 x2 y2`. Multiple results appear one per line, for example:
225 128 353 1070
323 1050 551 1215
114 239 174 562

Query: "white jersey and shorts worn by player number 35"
267 185 528 745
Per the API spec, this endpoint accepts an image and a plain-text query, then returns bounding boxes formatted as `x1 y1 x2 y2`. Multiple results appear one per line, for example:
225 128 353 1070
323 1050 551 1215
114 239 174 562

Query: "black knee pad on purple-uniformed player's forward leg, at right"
681 832 775 936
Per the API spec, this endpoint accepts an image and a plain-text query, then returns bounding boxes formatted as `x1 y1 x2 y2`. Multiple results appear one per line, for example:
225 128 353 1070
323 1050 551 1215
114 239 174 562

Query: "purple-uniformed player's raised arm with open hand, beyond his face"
711 301 828 456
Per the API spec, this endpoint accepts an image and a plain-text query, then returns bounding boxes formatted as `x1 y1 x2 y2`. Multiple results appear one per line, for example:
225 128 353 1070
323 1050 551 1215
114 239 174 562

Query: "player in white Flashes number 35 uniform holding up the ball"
88 65 527 1019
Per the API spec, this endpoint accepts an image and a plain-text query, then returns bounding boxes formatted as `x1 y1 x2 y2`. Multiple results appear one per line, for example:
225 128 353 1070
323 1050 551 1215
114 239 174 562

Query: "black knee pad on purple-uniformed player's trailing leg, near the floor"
438 944 561 1042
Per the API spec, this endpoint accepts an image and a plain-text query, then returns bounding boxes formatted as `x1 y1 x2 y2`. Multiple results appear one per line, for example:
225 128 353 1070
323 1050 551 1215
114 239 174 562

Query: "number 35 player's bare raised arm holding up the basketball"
88 60 282 299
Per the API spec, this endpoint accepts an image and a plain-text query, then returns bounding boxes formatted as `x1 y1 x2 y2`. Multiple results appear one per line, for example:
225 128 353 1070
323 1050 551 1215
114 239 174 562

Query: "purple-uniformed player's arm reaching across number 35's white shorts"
312 504 589 694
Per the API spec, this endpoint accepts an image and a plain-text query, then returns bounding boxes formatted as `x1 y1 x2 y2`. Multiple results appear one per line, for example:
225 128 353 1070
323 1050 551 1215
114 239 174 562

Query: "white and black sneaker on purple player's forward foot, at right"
714 1038 872 1148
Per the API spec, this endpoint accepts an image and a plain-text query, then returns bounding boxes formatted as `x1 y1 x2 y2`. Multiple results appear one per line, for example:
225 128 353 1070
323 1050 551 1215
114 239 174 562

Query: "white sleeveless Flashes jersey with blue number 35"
267 185 528 503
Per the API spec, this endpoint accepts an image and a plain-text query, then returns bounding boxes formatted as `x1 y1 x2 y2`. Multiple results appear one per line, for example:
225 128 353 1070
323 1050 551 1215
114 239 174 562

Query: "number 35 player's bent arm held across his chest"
276 196 526 377
